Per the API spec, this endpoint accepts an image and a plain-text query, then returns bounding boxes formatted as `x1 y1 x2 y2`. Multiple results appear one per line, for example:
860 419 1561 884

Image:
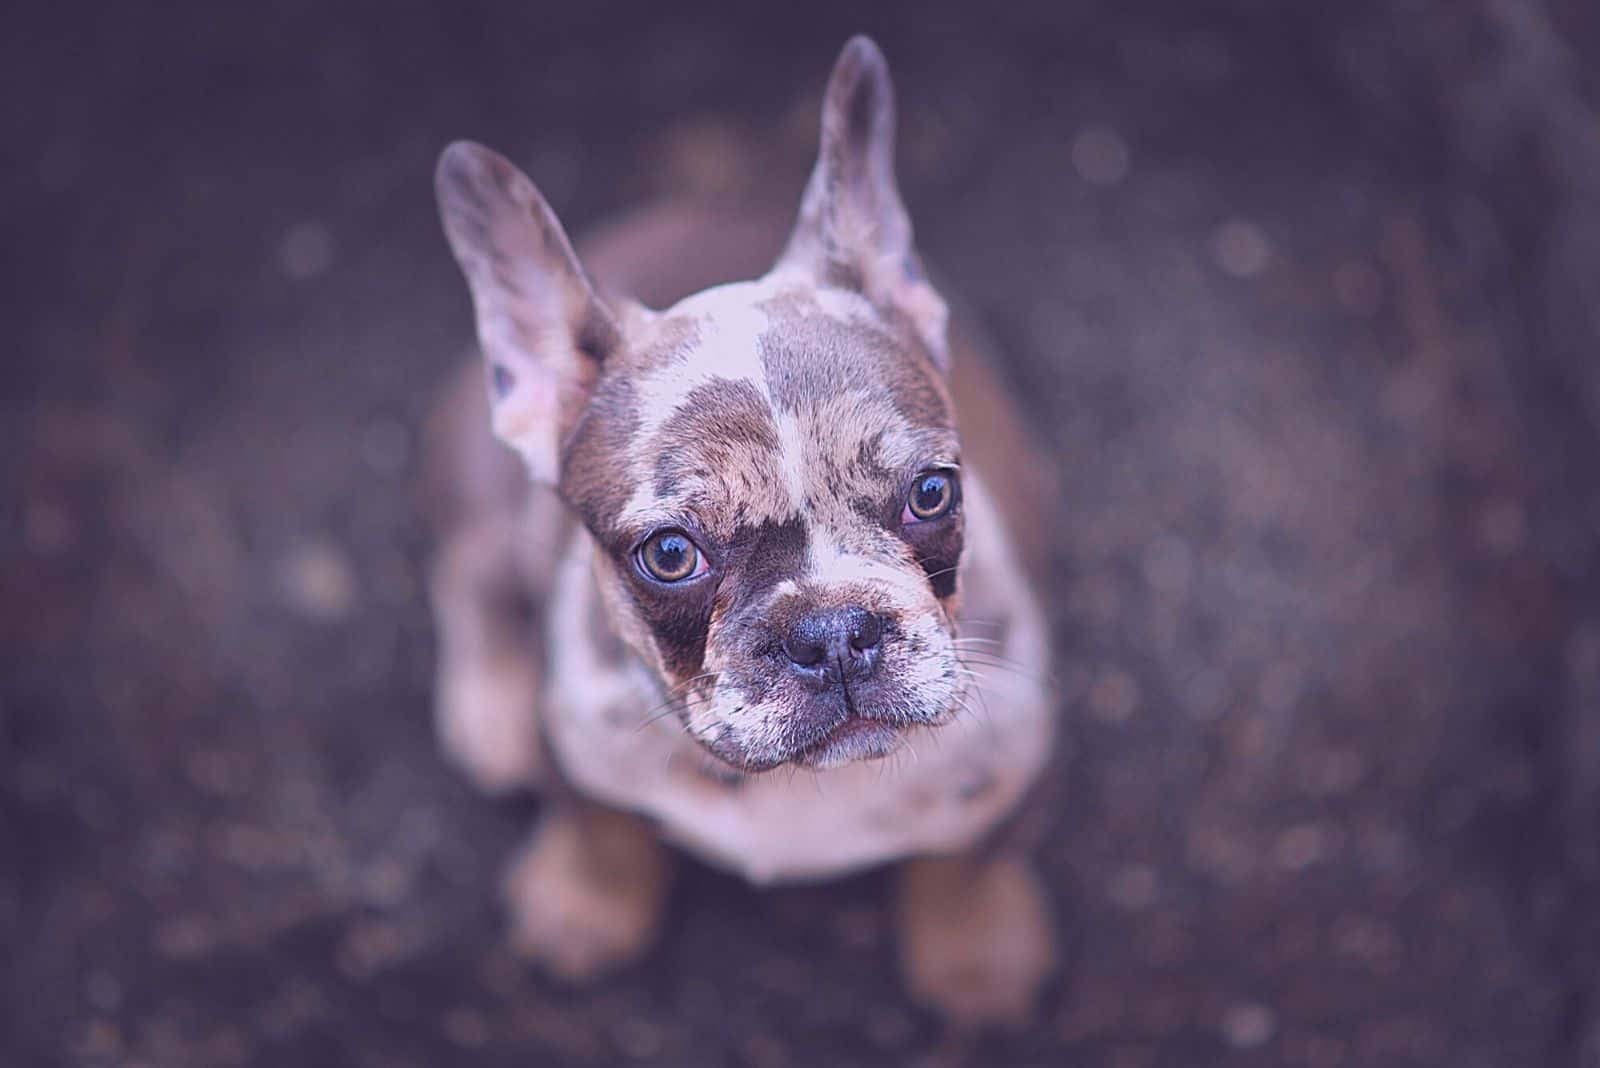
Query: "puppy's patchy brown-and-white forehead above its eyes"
562 281 957 537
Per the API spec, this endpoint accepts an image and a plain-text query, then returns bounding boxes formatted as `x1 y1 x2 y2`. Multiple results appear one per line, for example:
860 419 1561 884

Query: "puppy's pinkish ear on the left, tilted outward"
434 141 621 484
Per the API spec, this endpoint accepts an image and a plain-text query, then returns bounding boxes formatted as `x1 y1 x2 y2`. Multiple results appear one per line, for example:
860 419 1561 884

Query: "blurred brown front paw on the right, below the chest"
898 857 1056 1028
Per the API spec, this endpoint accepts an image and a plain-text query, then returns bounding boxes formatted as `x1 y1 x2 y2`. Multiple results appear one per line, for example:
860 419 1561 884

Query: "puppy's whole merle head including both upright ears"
438 38 965 771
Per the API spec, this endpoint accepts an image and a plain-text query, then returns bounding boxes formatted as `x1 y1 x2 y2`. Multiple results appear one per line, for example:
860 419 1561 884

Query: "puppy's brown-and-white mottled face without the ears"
560 278 962 769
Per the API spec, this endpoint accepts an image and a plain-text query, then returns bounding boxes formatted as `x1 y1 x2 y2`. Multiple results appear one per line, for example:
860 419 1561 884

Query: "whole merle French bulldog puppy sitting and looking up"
429 37 1054 1025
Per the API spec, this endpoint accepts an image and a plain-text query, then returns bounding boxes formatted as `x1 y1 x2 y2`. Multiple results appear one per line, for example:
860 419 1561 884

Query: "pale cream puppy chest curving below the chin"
546 668 1050 883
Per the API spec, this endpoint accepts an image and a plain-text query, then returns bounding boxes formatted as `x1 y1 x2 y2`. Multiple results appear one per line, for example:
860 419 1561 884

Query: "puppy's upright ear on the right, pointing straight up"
778 37 947 366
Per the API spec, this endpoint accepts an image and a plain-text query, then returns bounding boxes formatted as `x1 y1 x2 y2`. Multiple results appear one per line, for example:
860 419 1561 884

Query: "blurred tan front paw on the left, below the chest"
504 812 667 983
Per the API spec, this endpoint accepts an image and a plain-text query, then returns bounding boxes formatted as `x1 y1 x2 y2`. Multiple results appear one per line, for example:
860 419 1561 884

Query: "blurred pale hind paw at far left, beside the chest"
435 657 541 795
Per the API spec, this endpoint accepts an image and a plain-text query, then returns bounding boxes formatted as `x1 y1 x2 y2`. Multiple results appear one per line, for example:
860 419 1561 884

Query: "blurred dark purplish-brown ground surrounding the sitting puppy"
0 0 1600 1068
